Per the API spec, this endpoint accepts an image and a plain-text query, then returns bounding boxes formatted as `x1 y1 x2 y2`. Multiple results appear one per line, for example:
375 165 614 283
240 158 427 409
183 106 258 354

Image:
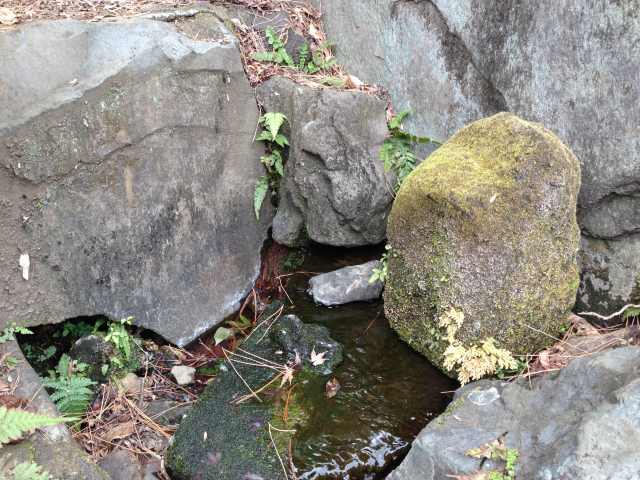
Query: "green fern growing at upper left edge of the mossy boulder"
379 110 441 192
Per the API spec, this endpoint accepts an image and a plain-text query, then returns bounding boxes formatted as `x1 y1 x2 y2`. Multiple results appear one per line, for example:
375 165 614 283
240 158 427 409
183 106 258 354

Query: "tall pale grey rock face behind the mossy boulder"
316 0 640 313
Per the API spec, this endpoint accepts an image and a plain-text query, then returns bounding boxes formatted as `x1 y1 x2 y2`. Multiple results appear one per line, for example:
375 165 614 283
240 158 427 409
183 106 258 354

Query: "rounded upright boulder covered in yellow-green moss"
384 113 580 375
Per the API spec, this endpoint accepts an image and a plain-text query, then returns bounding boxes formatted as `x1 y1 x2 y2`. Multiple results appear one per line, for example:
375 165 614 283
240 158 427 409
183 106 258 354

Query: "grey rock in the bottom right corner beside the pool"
389 347 640 480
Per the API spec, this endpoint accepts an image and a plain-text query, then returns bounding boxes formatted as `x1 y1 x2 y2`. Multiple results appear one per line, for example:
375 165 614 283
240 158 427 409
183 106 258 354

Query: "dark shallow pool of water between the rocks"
287 249 458 480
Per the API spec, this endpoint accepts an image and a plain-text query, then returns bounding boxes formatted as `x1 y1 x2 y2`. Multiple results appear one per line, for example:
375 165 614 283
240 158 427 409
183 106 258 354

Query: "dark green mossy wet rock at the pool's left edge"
166 315 342 480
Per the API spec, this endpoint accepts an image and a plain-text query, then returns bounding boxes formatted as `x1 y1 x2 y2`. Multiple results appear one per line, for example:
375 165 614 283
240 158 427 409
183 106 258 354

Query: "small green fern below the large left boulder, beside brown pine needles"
43 354 96 417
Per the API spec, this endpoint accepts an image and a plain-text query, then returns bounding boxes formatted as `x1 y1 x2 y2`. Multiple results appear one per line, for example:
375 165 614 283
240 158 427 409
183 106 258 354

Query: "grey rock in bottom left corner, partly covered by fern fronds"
0 340 110 480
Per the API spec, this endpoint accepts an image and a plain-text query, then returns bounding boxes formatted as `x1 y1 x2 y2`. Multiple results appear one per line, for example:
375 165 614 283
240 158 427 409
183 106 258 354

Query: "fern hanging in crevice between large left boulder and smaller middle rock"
253 112 289 220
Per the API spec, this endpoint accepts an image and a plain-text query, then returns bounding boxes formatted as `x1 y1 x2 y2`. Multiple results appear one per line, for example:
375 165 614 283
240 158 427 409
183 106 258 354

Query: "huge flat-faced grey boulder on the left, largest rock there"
0 13 270 345
